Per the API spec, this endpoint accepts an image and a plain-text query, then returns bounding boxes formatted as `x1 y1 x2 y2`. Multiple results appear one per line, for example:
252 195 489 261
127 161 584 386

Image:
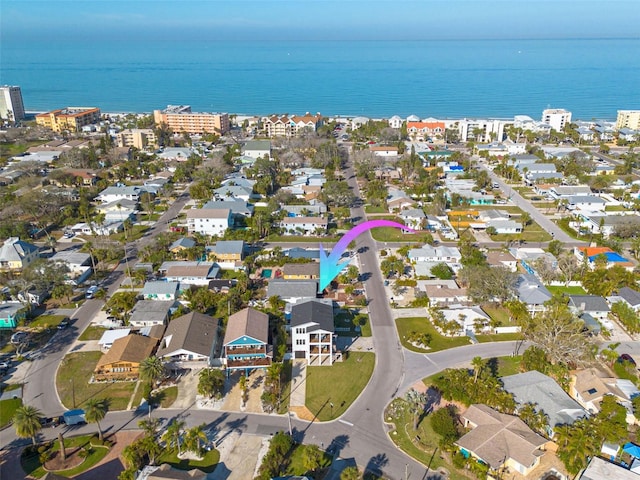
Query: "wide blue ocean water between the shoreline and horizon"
0 39 640 119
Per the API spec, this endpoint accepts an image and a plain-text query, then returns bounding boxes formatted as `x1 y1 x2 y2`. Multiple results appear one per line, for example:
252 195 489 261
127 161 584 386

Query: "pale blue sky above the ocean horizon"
0 0 640 40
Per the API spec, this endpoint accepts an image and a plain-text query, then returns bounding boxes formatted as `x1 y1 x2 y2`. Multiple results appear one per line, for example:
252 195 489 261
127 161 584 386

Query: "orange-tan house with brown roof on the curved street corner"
93 335 157 382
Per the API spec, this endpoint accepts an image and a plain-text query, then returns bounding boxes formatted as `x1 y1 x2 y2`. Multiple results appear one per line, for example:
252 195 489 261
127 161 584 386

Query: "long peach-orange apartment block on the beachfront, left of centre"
153 105 230 135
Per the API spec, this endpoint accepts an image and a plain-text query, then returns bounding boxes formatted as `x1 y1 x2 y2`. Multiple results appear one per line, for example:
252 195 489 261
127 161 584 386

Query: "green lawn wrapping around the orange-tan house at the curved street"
56 352 135 410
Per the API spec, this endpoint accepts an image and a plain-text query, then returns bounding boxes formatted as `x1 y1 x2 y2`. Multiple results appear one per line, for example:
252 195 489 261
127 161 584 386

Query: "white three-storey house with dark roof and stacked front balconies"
291 300 335 365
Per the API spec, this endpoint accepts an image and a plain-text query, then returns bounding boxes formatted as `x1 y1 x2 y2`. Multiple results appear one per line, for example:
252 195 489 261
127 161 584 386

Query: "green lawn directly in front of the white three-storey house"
306 352 375 421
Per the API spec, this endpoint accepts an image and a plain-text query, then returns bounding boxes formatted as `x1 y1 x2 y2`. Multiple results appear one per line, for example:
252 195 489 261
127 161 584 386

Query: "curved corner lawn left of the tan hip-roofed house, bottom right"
384 398 468 480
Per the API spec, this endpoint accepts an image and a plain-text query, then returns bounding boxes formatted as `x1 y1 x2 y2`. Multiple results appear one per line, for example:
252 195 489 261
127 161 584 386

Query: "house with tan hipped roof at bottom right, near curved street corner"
455 404 551 476
